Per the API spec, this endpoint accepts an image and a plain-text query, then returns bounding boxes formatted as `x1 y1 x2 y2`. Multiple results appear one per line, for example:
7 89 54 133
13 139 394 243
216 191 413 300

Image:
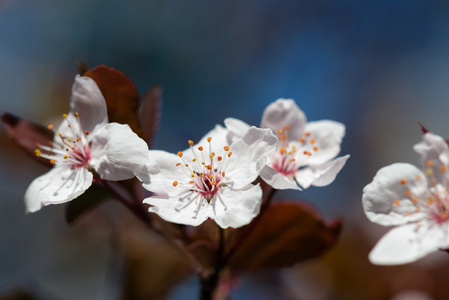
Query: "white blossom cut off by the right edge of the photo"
362 133 449 265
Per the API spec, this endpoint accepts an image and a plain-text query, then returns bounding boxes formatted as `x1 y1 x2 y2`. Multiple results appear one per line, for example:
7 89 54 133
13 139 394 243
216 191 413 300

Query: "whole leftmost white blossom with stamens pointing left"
25 76 148 212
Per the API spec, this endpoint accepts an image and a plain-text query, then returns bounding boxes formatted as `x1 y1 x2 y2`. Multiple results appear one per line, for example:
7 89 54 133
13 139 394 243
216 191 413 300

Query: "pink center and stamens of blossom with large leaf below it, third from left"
270 125 318 176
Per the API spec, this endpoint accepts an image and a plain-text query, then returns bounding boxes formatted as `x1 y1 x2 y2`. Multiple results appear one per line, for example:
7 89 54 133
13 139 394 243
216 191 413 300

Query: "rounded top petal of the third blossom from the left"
260 99 307 141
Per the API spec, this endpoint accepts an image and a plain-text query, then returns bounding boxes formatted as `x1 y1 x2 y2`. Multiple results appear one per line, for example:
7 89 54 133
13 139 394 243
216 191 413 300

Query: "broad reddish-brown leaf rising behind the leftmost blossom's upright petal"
84 66 142 137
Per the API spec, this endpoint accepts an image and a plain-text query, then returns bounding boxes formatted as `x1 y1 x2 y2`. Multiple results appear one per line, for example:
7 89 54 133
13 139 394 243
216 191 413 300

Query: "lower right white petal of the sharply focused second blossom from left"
210 184 262 228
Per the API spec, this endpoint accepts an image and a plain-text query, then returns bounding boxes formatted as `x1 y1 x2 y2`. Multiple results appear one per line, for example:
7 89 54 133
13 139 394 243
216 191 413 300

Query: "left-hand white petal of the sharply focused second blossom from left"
143 150 190 196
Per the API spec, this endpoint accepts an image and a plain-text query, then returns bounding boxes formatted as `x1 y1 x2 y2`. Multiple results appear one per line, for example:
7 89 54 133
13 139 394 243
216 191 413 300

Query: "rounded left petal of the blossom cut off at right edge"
362 163 428 226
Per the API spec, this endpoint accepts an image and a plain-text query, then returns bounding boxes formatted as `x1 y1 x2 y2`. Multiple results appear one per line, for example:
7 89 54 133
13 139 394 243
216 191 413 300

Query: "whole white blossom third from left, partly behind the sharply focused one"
225 99 349 189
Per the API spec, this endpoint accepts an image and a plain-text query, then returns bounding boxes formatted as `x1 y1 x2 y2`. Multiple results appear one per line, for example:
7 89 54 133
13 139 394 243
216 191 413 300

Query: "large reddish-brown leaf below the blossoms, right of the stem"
230 202 341 272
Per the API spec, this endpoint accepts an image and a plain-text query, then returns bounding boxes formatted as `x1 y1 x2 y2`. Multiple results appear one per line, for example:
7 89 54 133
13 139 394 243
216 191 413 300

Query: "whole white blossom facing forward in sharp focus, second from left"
143 125 276 228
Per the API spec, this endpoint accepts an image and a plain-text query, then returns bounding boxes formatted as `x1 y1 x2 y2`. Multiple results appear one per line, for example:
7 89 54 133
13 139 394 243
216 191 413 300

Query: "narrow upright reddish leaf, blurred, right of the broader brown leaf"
140 84 162 148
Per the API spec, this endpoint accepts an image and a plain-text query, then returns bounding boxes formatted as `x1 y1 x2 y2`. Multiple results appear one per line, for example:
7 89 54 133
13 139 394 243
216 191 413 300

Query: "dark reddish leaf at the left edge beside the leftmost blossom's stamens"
2 113 53 167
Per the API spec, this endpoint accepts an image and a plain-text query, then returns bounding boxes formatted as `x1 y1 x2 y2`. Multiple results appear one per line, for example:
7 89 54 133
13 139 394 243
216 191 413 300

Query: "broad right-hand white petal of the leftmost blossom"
88 123 148 180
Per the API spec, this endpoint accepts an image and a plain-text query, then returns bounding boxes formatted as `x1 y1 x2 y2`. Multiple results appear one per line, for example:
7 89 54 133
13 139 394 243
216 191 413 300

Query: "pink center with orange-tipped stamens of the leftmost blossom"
35 113 91 168
